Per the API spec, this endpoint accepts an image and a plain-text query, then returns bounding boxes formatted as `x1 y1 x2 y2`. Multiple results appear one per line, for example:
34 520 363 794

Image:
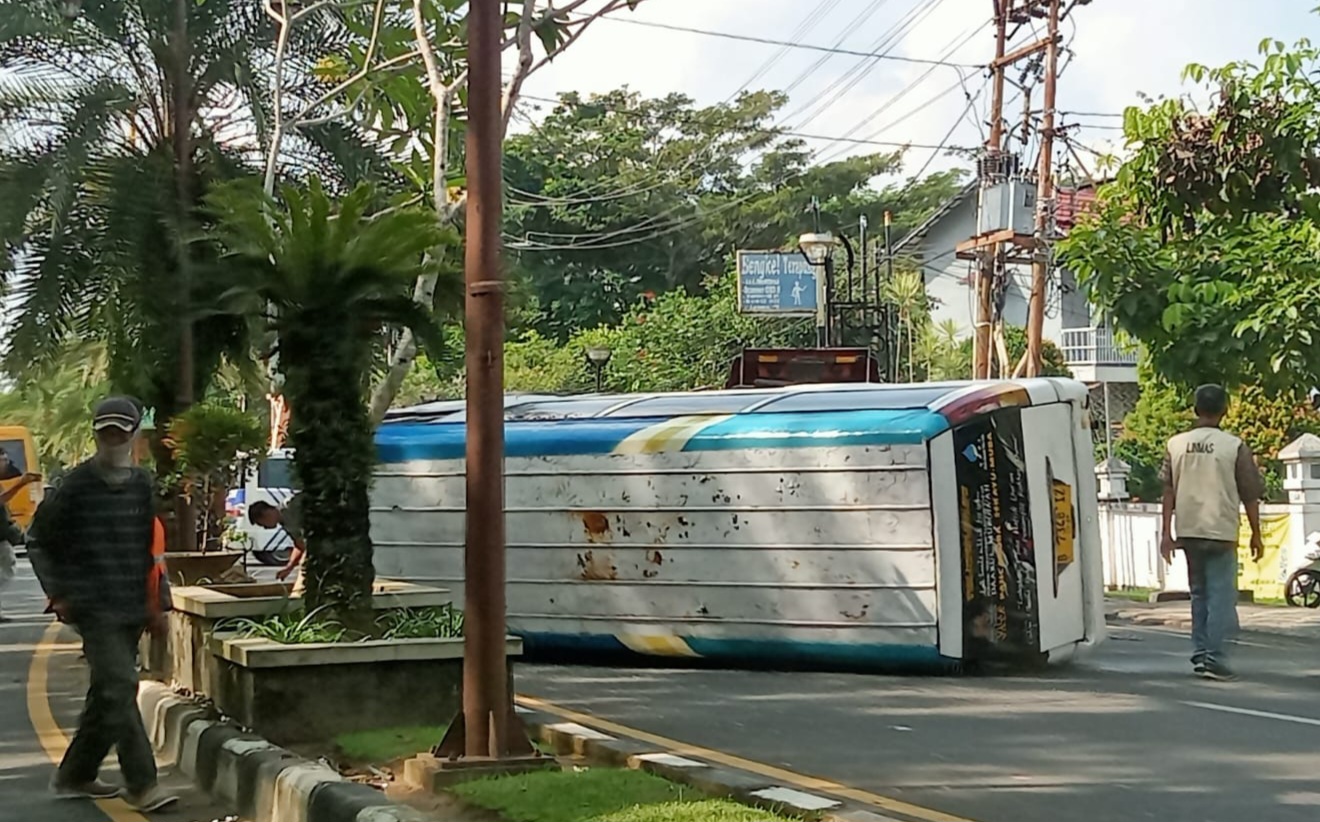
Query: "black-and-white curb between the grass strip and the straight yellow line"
517 706 900 822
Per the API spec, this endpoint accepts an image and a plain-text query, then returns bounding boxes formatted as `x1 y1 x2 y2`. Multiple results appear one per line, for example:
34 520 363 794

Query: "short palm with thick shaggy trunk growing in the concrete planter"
201 179 462 629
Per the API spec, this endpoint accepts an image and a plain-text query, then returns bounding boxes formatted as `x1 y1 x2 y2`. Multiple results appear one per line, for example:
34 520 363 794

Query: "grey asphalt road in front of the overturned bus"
516 627 1320 822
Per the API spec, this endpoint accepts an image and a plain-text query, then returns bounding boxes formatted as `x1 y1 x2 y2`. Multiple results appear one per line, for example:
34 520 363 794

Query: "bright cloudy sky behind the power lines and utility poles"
523 0 1320 183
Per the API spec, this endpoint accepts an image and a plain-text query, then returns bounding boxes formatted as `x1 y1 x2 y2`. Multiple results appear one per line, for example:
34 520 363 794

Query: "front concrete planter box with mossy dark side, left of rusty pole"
202 635 523 744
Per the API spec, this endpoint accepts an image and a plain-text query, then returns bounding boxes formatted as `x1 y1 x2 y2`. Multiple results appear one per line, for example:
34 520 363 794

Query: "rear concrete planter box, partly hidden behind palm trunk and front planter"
140 579 451 697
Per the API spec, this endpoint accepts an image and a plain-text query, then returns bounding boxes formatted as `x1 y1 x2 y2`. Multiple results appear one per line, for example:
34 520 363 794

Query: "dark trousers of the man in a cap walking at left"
59 623 156 793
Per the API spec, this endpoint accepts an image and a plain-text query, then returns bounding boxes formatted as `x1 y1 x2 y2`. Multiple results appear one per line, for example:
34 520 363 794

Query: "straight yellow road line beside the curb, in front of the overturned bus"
516 694 975 822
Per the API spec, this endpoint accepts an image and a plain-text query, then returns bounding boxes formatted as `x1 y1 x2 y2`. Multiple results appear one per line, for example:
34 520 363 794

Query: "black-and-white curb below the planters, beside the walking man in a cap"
137 682 430 822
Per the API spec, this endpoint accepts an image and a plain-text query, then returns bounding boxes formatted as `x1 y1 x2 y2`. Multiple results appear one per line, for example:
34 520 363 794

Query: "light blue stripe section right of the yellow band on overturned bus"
684 409 949 451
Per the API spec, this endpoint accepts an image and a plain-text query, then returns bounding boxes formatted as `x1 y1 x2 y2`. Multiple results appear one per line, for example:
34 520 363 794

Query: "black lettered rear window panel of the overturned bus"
953 408 1053 658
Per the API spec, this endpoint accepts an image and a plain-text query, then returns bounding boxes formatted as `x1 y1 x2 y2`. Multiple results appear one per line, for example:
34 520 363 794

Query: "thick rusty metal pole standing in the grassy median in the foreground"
463 0 510 759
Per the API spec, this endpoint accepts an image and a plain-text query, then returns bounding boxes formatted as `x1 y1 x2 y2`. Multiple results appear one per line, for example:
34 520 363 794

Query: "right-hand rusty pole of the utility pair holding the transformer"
1027 0 1060 377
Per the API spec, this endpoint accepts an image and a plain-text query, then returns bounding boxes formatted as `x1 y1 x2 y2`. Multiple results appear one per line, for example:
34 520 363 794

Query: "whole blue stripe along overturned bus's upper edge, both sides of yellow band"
376 409 949 463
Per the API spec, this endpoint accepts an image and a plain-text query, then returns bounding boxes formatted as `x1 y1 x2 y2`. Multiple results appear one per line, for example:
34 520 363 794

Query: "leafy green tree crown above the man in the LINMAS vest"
1060 32 1320 391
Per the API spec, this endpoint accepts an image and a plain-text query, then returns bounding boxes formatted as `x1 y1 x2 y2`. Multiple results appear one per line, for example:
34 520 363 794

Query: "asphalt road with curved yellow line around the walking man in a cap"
0 559 238 822
